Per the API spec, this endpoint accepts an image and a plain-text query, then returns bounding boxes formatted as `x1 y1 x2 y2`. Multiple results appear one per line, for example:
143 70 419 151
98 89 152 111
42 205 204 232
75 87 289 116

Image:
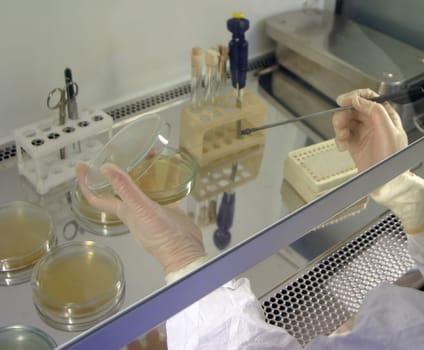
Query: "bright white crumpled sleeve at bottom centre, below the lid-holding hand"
166 278 302 350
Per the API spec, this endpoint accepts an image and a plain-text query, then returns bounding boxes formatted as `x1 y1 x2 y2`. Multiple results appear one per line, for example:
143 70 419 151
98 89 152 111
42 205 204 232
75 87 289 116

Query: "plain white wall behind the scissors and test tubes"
0 0 321 143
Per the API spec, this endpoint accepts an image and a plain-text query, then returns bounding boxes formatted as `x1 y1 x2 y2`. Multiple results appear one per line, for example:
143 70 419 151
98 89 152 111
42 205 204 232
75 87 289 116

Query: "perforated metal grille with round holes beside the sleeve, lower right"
262 215 413 346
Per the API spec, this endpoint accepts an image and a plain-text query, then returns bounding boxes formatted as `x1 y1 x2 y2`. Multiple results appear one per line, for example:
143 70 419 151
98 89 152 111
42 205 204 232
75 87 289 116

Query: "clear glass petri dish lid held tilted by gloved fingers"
86 114 170 190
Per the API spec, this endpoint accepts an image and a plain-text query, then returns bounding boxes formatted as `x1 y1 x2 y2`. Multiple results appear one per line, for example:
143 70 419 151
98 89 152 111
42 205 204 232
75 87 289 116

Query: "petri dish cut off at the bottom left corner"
0 325 57 350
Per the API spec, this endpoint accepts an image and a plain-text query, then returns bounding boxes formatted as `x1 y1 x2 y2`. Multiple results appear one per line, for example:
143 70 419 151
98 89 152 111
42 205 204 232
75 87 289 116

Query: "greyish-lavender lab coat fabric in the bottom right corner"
305 284 424 350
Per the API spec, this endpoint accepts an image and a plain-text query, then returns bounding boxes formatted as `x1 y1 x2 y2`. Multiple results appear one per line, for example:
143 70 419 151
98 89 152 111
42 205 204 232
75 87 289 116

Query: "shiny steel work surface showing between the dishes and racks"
0 75 344 345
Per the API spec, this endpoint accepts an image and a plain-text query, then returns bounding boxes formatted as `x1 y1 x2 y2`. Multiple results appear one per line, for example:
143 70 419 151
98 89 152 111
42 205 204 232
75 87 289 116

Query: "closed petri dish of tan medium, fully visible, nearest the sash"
31 241 125 331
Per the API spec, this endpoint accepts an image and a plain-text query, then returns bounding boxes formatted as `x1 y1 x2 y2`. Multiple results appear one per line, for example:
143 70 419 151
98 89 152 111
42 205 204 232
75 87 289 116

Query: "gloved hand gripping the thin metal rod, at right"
333 89 408 171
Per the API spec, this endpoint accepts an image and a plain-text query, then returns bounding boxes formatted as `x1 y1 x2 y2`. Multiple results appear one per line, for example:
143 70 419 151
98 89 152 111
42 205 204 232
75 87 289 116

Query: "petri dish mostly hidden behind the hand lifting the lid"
70 182 129 236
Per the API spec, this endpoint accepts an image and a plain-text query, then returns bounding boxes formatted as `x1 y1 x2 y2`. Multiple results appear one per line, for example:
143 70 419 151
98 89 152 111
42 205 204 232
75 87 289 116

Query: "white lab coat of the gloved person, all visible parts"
166 173 424 350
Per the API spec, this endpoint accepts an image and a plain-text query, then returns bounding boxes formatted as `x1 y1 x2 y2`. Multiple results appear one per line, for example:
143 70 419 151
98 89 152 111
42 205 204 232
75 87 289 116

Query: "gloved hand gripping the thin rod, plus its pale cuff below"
333 89 424 234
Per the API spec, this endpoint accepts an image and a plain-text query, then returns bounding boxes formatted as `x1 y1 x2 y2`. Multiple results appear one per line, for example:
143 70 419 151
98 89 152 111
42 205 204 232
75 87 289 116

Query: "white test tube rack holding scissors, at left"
13 110 113 195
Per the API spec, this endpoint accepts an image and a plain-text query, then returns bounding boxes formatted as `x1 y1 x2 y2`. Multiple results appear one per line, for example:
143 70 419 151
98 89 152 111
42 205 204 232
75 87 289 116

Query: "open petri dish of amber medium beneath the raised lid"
135 147 198 204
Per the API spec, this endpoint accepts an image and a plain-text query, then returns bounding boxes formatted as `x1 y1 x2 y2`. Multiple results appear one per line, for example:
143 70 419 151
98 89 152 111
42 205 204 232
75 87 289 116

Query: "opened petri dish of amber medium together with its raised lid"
80 114 198 205
